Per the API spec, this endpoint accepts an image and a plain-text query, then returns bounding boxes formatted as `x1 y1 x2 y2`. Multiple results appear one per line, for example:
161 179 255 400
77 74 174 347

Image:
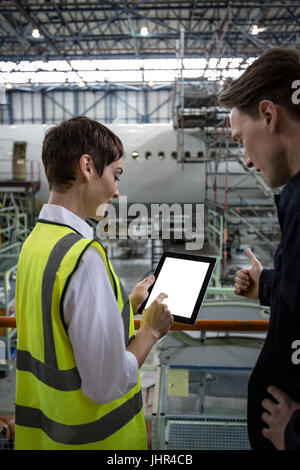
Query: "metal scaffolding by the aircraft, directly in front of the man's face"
173 32 281 286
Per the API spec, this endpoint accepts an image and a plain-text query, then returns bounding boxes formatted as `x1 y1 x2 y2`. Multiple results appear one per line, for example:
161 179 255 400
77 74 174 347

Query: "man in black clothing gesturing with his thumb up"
219 48 300 449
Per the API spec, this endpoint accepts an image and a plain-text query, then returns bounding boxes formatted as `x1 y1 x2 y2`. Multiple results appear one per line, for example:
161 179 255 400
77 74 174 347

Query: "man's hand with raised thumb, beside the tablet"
234 248 263 299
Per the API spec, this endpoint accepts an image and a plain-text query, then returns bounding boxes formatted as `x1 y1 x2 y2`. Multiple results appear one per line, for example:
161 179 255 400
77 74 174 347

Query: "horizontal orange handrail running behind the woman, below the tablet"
0 316 269 332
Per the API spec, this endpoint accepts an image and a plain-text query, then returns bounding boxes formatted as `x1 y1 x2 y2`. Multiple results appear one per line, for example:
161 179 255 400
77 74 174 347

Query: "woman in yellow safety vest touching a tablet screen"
15 117 173 450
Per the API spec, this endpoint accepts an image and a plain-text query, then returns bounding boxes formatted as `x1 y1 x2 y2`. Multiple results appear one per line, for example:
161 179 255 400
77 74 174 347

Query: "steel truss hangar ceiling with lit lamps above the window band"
0 0 300 62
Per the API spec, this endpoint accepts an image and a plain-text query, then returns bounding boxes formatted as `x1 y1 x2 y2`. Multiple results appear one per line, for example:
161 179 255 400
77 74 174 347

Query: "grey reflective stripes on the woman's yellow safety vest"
16 229 143 445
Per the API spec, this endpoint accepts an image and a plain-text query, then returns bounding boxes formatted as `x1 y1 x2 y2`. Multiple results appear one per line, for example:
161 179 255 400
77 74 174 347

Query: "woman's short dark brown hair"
42 116 124 190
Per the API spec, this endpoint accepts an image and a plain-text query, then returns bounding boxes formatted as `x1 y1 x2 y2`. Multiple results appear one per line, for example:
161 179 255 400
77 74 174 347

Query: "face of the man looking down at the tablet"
230 108 289 188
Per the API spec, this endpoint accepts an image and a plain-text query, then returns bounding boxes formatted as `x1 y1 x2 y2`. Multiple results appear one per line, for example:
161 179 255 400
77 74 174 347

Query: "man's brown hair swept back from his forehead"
219 47 300 120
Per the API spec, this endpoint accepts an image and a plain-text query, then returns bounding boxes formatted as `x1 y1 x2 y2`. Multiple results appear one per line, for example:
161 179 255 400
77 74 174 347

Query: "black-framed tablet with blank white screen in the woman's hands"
139 252 216 325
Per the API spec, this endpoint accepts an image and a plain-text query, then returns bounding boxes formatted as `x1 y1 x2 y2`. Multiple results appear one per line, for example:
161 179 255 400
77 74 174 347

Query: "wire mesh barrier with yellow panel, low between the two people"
153 366 251 450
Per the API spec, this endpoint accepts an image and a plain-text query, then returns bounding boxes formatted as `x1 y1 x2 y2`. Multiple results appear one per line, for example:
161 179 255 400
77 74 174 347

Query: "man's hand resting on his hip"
261 386 300 450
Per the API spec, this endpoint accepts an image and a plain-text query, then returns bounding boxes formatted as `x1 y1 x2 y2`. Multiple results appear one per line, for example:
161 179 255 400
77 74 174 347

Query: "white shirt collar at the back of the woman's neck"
39 204 94 240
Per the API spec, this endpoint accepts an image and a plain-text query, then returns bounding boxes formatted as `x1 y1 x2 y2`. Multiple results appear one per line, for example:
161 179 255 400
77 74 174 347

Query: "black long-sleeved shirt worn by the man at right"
248 172 300 450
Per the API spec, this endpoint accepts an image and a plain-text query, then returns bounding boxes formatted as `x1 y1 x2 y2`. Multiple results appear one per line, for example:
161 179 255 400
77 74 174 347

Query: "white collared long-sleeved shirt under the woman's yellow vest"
39 204 138 403
